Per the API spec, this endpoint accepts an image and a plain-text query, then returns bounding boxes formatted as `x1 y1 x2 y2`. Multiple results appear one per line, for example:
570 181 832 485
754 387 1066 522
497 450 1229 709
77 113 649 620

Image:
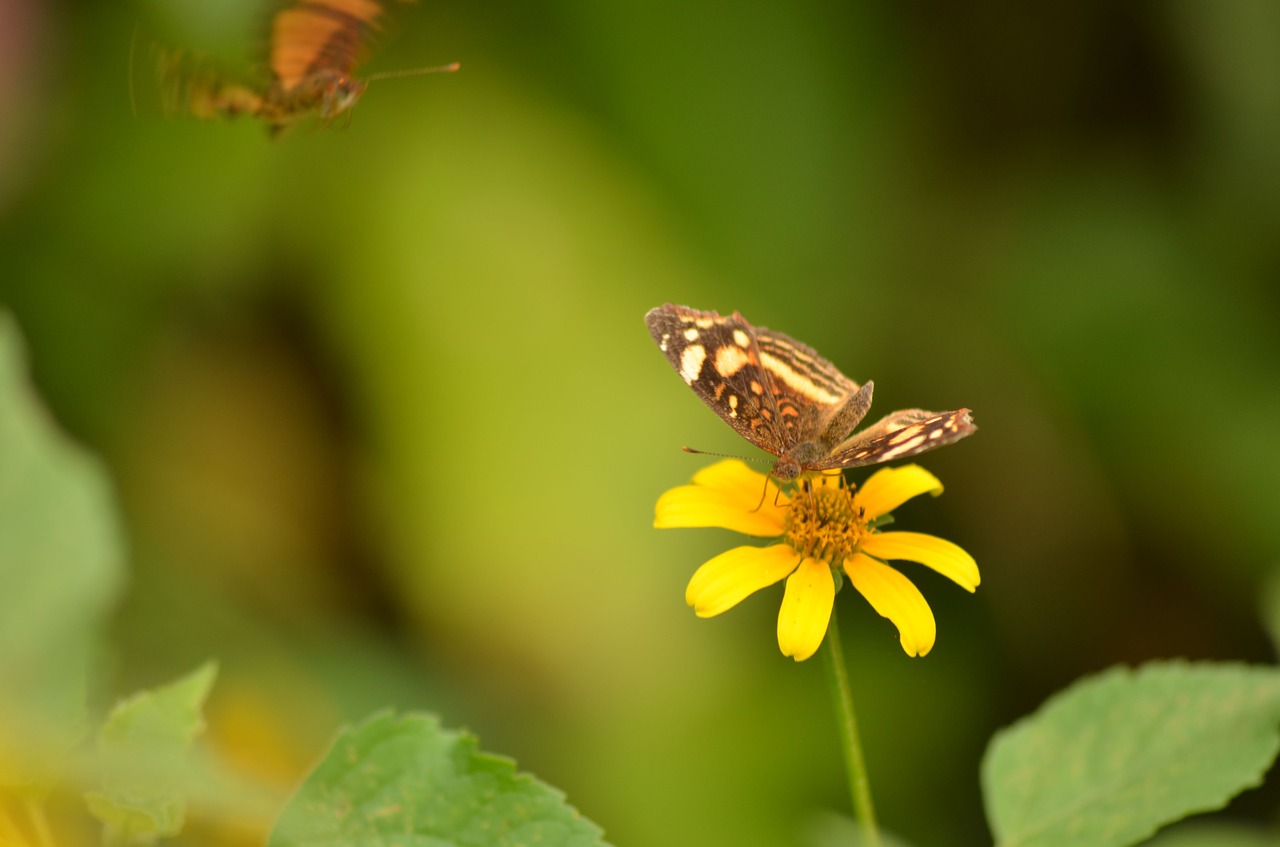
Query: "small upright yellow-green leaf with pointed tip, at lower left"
84 663 218 843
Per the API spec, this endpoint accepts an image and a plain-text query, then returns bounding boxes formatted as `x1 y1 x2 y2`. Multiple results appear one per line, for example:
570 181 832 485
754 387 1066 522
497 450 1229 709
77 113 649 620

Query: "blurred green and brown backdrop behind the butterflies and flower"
0 0 1280 847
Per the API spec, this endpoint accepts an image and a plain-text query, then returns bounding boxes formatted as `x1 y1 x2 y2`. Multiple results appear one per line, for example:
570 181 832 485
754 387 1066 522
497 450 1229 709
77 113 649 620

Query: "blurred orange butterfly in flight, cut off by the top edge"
151 0 458 137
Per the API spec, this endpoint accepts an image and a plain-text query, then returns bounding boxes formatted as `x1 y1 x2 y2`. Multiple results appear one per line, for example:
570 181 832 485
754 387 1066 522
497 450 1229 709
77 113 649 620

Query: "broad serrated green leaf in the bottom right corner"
982 661 1280 847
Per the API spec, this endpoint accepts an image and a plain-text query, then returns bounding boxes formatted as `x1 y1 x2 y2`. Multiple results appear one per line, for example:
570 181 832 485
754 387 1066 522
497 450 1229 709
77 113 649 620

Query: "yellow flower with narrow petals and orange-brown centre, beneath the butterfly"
653 459 979 661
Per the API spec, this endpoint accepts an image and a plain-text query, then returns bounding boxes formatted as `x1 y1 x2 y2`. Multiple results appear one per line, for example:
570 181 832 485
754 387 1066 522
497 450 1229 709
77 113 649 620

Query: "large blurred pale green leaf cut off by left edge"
0 311 123 786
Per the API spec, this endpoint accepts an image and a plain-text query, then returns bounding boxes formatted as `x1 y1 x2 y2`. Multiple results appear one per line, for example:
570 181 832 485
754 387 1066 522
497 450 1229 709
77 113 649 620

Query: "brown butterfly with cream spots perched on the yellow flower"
645 303 978 482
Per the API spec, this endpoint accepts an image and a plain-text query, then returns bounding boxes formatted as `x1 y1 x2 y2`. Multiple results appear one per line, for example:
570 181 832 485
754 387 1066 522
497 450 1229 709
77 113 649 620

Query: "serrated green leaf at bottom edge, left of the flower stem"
268 713 604 847
